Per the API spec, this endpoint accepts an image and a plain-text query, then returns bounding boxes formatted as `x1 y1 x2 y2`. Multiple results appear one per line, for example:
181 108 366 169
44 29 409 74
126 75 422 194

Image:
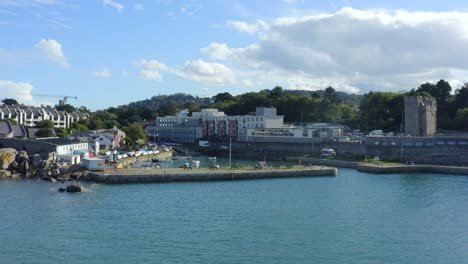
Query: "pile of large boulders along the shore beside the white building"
0 148 90 182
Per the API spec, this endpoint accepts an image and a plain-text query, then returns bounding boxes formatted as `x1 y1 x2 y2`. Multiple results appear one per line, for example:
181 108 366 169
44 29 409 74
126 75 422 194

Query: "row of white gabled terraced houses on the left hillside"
0 105 89 129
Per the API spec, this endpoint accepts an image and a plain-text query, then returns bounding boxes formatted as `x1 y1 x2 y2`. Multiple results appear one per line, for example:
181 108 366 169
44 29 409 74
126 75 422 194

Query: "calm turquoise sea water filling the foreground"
0 169 468 264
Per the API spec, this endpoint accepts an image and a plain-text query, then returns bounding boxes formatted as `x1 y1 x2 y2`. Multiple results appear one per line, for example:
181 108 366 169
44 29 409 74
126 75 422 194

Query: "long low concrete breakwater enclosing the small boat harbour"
89 167 338 183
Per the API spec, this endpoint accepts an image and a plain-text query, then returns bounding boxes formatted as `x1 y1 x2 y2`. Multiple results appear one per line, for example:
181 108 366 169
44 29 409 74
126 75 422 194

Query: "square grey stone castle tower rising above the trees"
405 96 437 137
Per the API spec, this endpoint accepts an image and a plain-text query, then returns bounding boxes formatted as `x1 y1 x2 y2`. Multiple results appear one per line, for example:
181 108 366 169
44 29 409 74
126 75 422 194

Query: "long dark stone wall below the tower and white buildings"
204 138 468 166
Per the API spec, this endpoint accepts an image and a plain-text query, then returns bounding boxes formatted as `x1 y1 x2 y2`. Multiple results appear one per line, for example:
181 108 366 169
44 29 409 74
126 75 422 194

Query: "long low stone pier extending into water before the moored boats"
89 168 338 183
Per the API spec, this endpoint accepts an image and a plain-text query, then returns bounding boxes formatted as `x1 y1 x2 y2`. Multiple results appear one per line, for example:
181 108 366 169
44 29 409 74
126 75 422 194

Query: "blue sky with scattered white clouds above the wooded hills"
0 0 468 110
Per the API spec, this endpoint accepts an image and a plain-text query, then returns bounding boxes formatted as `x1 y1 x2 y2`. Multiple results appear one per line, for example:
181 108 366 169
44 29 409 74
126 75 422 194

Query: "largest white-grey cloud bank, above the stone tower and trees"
201 8 468 92
